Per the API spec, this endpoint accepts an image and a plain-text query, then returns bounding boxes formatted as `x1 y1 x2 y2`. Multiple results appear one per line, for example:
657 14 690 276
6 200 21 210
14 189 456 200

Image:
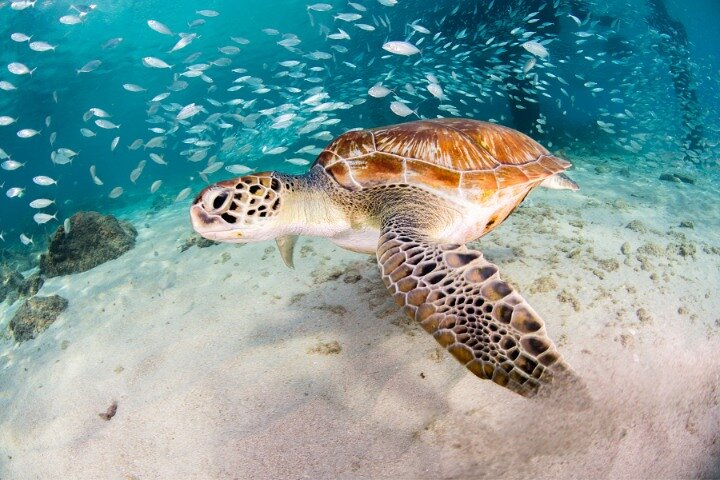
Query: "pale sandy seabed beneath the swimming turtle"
0 159 720 479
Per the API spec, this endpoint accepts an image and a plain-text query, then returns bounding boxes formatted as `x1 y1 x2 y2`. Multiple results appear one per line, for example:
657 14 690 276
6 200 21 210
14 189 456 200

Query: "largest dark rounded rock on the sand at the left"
40 212 137 277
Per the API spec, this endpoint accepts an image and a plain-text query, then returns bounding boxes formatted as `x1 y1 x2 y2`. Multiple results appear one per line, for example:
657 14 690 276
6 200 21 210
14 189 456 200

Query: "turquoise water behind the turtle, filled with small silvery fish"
0 0 720 251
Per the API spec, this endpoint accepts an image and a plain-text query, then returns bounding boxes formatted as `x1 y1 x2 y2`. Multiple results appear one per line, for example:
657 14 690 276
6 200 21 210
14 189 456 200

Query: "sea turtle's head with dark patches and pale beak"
190 172 290 243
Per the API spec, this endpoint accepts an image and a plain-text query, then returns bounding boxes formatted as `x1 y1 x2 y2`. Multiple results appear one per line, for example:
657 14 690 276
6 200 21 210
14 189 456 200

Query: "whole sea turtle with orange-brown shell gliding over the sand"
190 119 578 396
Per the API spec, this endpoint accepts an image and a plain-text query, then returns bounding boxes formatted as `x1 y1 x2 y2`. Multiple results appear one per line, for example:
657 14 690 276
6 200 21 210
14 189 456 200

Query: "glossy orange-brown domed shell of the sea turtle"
315 119 570 198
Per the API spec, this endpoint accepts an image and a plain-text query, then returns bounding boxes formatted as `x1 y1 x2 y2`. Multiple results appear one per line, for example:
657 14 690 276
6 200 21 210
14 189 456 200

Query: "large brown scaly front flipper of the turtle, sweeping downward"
377 220 584 397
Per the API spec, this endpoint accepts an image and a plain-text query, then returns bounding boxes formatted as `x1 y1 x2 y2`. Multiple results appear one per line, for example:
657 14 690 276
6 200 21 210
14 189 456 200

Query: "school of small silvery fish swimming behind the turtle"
0 0 720 245
